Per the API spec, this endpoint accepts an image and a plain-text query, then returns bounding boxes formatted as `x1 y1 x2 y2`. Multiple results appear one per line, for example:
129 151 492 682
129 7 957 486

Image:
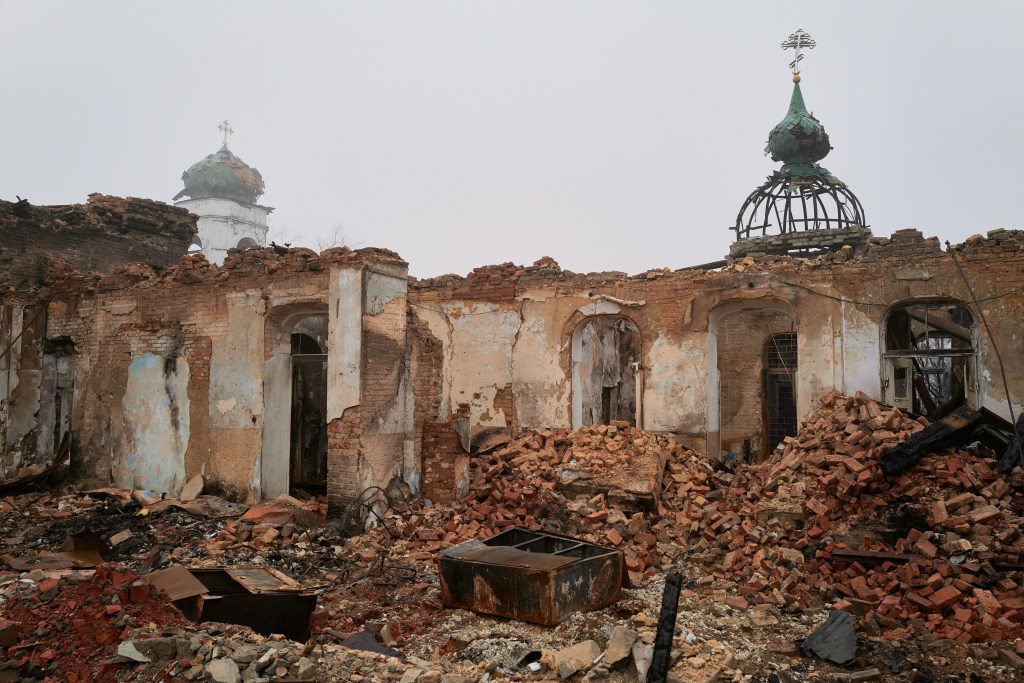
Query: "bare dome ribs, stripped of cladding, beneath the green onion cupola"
733 171 866 241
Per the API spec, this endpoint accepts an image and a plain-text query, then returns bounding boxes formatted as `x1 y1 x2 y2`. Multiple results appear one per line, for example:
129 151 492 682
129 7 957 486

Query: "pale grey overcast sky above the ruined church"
0 0 1024 276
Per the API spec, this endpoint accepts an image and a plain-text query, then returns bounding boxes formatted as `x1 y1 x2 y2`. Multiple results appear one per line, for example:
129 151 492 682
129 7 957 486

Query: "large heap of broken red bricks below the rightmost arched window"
667 392 1024 643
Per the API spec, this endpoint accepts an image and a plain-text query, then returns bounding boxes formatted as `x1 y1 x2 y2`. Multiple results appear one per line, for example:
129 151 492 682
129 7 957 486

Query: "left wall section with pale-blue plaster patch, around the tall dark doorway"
28 242 407 500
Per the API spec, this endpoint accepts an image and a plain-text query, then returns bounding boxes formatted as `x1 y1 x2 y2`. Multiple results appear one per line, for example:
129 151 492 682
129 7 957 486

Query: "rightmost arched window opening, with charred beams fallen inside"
883 300 976 420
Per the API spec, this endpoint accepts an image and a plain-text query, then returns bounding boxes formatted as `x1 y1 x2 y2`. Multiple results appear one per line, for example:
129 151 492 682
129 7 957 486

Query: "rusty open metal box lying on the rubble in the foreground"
437 526 623 626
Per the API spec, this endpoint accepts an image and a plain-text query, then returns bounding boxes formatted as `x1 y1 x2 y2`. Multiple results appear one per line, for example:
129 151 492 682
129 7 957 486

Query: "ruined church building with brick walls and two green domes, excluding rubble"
0 58 1024 512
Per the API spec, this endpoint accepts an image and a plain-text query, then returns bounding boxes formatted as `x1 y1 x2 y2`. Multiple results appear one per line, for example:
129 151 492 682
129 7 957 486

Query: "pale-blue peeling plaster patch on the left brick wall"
112 353 189 492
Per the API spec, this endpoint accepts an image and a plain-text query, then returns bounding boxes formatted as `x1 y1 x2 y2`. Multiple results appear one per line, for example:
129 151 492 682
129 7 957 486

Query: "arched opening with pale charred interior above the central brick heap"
572 315 641 429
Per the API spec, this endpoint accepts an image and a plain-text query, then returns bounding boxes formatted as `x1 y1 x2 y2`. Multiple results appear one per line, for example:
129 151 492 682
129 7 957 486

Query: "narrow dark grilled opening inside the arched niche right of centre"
761 332 797 449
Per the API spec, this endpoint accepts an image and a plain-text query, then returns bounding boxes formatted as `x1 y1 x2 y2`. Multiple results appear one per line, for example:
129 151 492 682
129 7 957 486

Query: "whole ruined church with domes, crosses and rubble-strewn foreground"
0 31 1024 683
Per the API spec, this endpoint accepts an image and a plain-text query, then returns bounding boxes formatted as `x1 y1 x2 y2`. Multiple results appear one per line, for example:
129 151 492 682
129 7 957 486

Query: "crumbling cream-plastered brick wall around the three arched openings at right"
410 230 1024 453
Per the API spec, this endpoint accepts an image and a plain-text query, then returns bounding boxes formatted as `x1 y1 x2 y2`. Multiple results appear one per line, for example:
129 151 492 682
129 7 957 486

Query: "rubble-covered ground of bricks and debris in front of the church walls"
0 392 1024 683
